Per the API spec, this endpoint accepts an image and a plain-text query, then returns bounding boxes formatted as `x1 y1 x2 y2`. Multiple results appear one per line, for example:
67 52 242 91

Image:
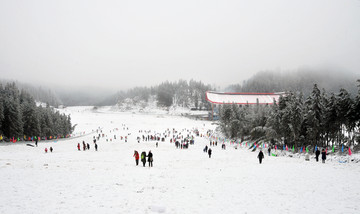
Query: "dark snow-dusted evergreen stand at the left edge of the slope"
0 83 73 140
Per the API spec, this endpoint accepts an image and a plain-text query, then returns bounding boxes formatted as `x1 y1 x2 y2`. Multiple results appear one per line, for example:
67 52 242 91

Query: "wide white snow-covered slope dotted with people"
0 107 360 214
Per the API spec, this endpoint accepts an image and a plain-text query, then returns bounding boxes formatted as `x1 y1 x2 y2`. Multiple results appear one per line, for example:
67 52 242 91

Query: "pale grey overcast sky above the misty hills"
0 0 360 89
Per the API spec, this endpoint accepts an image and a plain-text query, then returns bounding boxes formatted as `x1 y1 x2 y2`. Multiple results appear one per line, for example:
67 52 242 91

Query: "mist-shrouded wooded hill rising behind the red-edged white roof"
225 69 359 96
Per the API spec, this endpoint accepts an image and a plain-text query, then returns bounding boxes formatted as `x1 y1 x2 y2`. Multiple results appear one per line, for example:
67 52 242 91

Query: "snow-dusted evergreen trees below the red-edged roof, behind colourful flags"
219 80 360 148
